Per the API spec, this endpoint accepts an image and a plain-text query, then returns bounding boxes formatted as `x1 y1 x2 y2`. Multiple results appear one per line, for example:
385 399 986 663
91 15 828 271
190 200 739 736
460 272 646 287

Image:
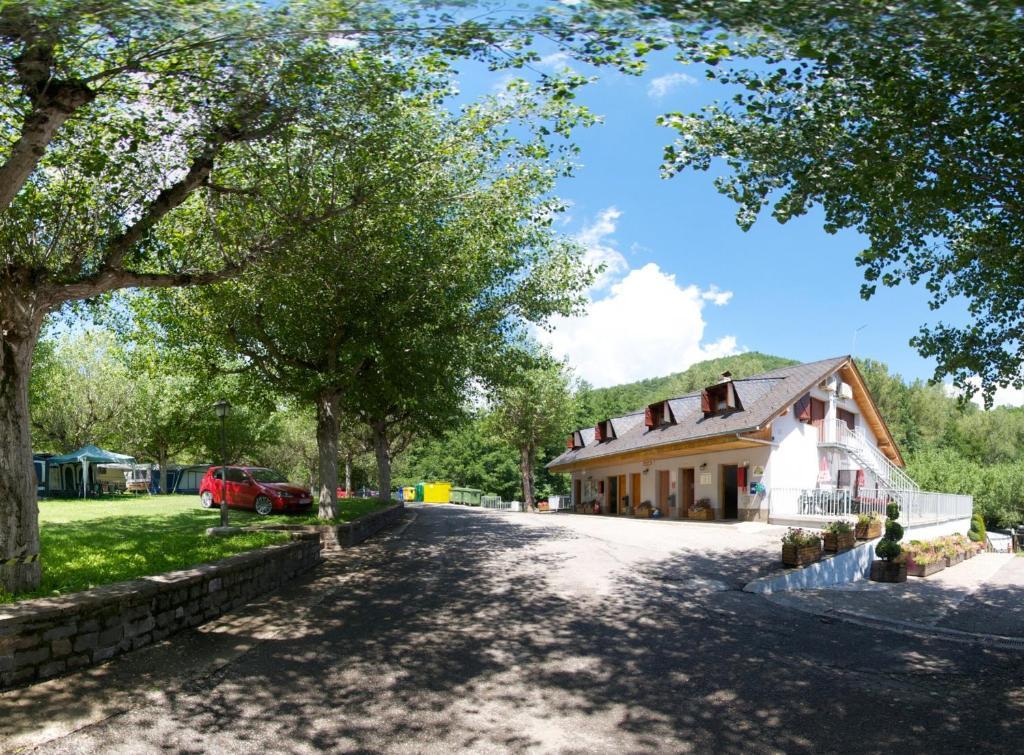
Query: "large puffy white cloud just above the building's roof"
538 262 740 387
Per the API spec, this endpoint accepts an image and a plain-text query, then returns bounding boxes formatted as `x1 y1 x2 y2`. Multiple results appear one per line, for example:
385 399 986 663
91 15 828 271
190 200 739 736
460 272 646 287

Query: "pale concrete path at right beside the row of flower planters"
768 553 1024 637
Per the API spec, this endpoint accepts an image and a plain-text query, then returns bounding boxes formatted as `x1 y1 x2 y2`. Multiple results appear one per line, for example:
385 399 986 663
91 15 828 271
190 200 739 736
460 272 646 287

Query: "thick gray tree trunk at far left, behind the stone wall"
0 303 41 593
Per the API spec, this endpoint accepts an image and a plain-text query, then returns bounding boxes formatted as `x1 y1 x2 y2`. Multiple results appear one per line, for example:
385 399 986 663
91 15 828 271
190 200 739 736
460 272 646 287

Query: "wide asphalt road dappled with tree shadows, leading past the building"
8 507 1024 753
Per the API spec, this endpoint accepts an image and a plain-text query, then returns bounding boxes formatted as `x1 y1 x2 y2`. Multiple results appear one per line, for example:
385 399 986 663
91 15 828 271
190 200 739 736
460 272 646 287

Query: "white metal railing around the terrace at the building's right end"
768 488 974 525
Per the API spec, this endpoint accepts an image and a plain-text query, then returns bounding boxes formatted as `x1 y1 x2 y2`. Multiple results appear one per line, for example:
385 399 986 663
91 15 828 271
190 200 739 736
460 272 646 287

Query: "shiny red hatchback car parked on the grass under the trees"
199 467 313 516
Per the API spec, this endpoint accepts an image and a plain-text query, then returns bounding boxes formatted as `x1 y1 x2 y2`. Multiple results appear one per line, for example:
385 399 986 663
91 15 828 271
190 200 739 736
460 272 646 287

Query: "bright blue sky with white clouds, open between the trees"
460 54 1024 405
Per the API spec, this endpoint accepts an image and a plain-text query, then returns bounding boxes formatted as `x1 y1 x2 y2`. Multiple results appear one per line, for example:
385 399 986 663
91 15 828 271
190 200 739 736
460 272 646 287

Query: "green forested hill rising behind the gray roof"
579 351 799 427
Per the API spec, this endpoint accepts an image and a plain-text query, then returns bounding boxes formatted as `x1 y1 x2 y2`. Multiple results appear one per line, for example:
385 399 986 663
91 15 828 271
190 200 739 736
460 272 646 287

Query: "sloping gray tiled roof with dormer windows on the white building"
548 356 850 467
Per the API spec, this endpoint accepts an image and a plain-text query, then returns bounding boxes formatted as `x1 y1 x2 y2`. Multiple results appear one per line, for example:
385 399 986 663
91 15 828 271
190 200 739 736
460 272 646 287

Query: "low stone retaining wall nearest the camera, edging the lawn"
0 534 321 688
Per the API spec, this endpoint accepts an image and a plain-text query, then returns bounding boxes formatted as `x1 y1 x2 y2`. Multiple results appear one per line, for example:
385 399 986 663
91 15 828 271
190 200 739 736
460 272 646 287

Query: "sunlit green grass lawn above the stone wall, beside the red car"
0 496 380 603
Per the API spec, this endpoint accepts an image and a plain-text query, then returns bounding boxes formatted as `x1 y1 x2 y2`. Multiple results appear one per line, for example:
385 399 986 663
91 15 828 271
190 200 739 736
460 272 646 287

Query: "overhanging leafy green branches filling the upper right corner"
614 0 1024 399
